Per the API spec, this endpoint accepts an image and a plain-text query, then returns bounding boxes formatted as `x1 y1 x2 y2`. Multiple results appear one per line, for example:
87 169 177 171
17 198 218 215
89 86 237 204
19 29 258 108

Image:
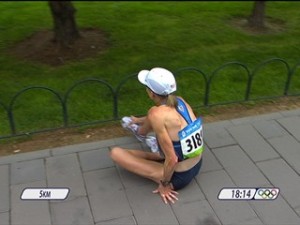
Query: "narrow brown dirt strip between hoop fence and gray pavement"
0 97 300 156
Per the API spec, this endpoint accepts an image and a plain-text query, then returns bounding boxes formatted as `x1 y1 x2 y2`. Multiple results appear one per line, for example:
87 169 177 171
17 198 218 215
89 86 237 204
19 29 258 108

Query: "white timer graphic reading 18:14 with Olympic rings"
218 187 279 200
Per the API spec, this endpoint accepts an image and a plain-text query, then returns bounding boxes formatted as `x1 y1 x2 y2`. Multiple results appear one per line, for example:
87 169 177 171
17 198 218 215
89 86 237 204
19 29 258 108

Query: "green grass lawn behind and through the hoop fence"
0 1 300 136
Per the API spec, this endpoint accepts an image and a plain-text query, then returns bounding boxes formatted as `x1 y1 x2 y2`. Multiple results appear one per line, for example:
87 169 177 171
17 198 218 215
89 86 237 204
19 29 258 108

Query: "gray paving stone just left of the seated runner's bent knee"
79 147 114 172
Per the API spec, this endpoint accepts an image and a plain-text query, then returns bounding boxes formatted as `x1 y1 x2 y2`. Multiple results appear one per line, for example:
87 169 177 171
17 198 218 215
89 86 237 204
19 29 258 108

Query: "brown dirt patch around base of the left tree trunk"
8 28 109 66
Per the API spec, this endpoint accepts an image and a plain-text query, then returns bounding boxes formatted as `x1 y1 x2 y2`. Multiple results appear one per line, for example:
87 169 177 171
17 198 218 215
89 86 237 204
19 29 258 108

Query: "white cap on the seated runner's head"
138 67 176 96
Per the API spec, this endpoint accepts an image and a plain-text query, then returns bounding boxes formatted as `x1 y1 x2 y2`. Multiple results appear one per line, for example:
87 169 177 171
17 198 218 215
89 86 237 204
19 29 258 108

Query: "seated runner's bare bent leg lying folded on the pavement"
110 147 163 183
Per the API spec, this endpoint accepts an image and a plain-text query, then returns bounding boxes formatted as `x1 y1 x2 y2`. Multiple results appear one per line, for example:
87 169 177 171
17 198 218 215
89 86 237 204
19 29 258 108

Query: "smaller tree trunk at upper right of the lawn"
248 1 265 29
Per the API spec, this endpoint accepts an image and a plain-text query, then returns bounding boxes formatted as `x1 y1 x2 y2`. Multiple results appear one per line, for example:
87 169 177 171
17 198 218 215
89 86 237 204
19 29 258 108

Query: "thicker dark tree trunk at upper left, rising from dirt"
48 1 80 47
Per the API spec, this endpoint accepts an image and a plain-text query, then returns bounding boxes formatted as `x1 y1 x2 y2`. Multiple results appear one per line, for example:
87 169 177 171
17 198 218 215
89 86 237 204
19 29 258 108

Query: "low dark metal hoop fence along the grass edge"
0 58 300 139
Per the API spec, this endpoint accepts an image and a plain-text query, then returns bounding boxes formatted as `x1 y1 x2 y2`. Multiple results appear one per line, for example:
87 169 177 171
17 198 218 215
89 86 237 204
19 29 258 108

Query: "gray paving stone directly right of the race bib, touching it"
203 126 236 148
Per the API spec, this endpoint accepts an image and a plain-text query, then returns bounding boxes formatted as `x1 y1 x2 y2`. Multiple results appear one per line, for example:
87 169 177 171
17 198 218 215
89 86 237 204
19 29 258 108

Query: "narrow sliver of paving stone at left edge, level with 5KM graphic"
0 165 10 214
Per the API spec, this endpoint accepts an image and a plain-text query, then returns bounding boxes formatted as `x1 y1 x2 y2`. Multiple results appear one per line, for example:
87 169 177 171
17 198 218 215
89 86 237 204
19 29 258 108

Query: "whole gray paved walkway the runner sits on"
0 109 300 225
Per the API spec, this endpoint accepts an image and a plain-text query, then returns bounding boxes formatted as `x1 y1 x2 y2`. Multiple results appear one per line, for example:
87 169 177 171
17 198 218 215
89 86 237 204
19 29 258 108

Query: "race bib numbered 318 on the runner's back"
178 118 203 159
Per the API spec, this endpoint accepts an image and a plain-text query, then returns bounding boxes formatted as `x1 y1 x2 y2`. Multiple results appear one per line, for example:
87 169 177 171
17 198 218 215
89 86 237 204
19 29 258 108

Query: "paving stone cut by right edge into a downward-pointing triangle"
269 136 300 175
